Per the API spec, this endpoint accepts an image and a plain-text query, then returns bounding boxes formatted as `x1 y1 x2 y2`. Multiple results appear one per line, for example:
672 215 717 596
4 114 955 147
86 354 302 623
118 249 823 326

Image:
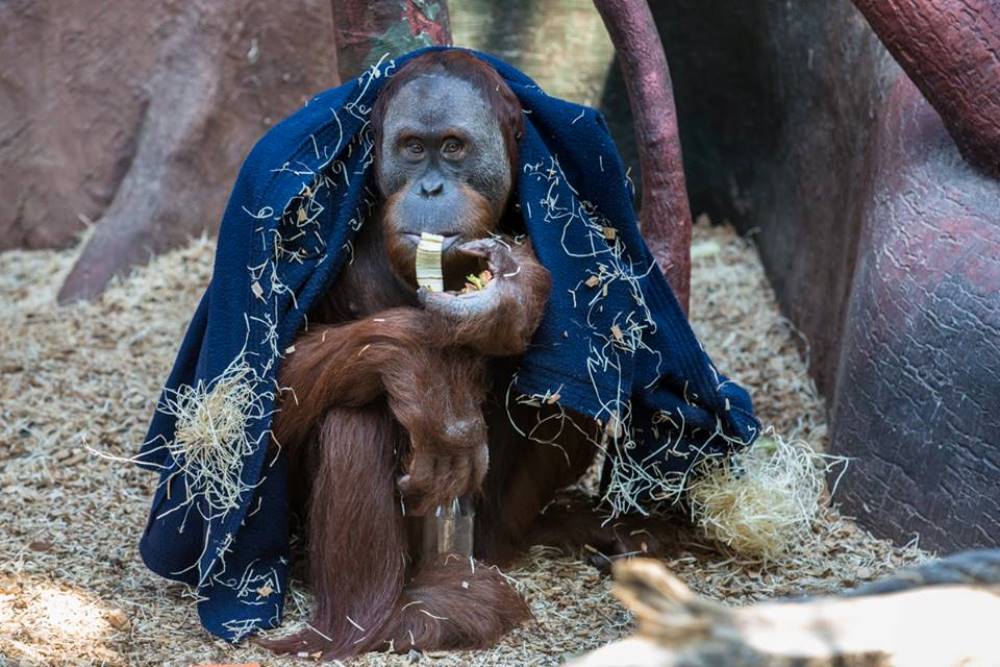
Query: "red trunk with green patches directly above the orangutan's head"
331 0 451 81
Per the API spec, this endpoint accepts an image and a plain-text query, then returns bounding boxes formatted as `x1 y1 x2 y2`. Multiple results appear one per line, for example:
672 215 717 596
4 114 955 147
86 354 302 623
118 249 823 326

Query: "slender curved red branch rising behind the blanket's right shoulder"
594 0 691 311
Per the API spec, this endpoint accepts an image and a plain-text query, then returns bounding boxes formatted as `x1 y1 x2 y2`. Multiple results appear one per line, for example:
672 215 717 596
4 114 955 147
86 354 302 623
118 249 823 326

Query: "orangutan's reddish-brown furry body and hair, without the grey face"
263 53 594 659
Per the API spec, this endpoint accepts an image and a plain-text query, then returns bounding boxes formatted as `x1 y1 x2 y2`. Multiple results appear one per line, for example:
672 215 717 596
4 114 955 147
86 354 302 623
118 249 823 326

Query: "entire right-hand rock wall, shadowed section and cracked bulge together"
640 0 1000 550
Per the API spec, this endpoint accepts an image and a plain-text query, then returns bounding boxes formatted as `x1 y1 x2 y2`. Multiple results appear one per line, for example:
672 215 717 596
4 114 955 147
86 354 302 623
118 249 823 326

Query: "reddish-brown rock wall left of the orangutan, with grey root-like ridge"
0 0 336 288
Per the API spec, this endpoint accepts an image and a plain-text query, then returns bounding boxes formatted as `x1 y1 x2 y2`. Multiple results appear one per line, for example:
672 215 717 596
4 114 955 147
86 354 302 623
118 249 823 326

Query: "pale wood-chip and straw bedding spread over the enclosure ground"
0 225 921 665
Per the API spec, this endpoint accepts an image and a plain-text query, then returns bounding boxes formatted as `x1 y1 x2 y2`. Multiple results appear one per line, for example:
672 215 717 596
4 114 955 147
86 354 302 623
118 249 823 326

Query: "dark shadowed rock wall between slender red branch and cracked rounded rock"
603 0 899 395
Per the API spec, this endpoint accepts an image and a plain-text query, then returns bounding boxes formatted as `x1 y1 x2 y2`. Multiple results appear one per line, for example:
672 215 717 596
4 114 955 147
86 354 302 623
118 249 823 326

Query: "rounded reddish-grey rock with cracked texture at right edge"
833 77 1000 551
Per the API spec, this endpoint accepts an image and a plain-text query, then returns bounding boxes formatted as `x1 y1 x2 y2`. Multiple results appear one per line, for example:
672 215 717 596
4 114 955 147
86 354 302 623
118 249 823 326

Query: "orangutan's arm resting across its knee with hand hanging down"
273 308 488 512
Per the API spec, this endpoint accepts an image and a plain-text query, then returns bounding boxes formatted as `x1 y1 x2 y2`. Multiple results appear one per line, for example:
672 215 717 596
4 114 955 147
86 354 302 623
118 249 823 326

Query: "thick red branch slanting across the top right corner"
854 0 1000 178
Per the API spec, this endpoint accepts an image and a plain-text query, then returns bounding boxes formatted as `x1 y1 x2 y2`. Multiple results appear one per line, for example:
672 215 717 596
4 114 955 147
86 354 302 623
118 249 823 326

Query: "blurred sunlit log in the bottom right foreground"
570 550 1000 667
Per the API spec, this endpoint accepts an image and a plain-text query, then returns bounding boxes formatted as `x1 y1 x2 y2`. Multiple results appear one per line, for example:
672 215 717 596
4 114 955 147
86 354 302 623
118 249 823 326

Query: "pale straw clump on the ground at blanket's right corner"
688 435 839 561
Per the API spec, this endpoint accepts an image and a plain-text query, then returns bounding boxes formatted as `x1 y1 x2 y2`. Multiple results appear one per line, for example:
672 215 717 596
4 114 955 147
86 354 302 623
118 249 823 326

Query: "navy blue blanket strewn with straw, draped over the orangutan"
139 51 758 640
